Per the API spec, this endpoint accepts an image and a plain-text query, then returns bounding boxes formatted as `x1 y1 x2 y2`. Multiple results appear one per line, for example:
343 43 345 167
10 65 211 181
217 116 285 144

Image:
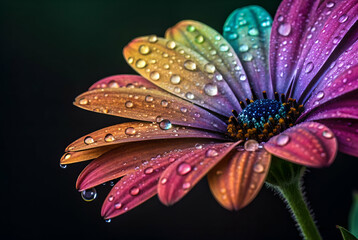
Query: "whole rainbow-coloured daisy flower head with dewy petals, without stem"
61 0 358 219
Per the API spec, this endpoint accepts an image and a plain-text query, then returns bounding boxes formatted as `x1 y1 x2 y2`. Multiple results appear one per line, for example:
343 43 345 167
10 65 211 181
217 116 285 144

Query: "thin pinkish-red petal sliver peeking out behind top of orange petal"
89 74 158 90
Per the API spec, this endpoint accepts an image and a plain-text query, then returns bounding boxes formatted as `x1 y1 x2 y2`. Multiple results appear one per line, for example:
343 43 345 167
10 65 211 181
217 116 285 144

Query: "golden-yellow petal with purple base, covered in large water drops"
123 36 240 116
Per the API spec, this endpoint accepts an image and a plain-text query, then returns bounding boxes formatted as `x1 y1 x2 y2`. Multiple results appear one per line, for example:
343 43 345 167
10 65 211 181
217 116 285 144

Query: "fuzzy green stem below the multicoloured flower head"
276 181 322 240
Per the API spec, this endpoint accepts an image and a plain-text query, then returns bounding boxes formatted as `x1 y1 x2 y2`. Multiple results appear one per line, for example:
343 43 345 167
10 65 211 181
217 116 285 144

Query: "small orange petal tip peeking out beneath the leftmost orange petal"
60 145 116 164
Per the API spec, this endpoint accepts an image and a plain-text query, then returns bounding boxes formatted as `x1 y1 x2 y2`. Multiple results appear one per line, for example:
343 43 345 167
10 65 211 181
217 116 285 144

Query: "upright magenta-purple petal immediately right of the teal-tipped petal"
270 0 320 93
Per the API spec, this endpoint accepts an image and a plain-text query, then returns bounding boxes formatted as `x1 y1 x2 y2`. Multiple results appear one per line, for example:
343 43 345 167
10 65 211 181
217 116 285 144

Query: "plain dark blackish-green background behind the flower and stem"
0 0 358 240
